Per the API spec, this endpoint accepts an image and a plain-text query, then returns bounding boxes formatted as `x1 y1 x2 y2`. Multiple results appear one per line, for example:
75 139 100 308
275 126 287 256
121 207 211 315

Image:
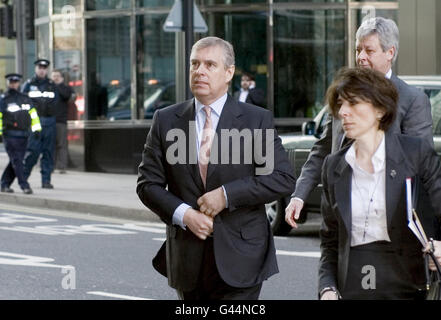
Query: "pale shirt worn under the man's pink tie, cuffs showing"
172 93 228 230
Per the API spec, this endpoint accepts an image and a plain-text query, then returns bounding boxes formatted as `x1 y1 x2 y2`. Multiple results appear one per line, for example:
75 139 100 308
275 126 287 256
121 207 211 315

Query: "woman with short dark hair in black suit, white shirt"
319 68 441 299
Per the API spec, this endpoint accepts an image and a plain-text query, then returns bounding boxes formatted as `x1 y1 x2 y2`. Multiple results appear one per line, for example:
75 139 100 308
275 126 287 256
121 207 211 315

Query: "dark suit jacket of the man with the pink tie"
137 96 295 291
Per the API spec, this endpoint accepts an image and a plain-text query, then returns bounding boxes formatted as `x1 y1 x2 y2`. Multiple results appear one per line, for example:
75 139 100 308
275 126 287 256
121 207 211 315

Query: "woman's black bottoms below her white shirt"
340 241 425 300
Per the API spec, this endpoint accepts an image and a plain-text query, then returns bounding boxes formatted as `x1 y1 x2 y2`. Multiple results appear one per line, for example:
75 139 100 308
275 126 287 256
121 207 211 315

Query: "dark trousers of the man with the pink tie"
176 237 262 301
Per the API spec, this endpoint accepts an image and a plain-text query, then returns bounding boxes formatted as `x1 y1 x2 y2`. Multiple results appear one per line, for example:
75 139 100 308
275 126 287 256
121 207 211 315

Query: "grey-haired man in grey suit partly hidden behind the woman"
285 17 433 227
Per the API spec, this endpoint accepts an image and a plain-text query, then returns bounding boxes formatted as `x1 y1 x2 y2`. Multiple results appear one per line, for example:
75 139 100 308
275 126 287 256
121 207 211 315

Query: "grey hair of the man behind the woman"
356 17 400 64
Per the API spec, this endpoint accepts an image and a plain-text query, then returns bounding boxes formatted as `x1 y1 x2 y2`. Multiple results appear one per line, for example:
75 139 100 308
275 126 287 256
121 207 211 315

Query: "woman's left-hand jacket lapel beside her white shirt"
334 153 352 237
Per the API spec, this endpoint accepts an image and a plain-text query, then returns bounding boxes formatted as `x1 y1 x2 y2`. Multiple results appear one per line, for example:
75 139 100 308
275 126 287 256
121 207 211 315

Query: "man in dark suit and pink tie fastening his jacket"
137 37 295 300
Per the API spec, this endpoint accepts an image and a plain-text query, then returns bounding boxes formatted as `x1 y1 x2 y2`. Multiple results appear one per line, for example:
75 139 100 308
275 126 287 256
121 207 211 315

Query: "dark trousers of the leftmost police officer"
1 136 29 189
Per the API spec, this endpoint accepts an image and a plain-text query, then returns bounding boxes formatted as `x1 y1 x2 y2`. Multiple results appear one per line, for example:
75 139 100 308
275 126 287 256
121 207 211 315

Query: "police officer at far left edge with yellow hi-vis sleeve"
0 73 41 194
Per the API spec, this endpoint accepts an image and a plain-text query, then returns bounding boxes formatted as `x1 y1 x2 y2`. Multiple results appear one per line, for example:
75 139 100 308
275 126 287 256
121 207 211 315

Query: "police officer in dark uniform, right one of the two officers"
23 59 57 189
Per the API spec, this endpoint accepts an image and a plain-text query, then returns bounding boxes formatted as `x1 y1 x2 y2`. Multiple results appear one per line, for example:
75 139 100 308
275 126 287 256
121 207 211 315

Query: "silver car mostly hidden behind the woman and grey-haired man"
266 76 441 235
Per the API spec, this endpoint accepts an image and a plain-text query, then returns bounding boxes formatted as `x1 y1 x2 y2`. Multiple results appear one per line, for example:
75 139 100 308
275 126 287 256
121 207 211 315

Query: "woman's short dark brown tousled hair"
326 67 398 131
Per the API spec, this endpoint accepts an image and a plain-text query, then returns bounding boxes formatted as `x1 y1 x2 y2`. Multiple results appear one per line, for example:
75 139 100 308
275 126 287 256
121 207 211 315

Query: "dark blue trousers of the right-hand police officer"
24 117 57 184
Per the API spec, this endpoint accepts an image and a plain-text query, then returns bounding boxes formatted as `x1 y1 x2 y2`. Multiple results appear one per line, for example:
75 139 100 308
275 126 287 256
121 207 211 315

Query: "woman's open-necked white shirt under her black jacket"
345 136 391 247
